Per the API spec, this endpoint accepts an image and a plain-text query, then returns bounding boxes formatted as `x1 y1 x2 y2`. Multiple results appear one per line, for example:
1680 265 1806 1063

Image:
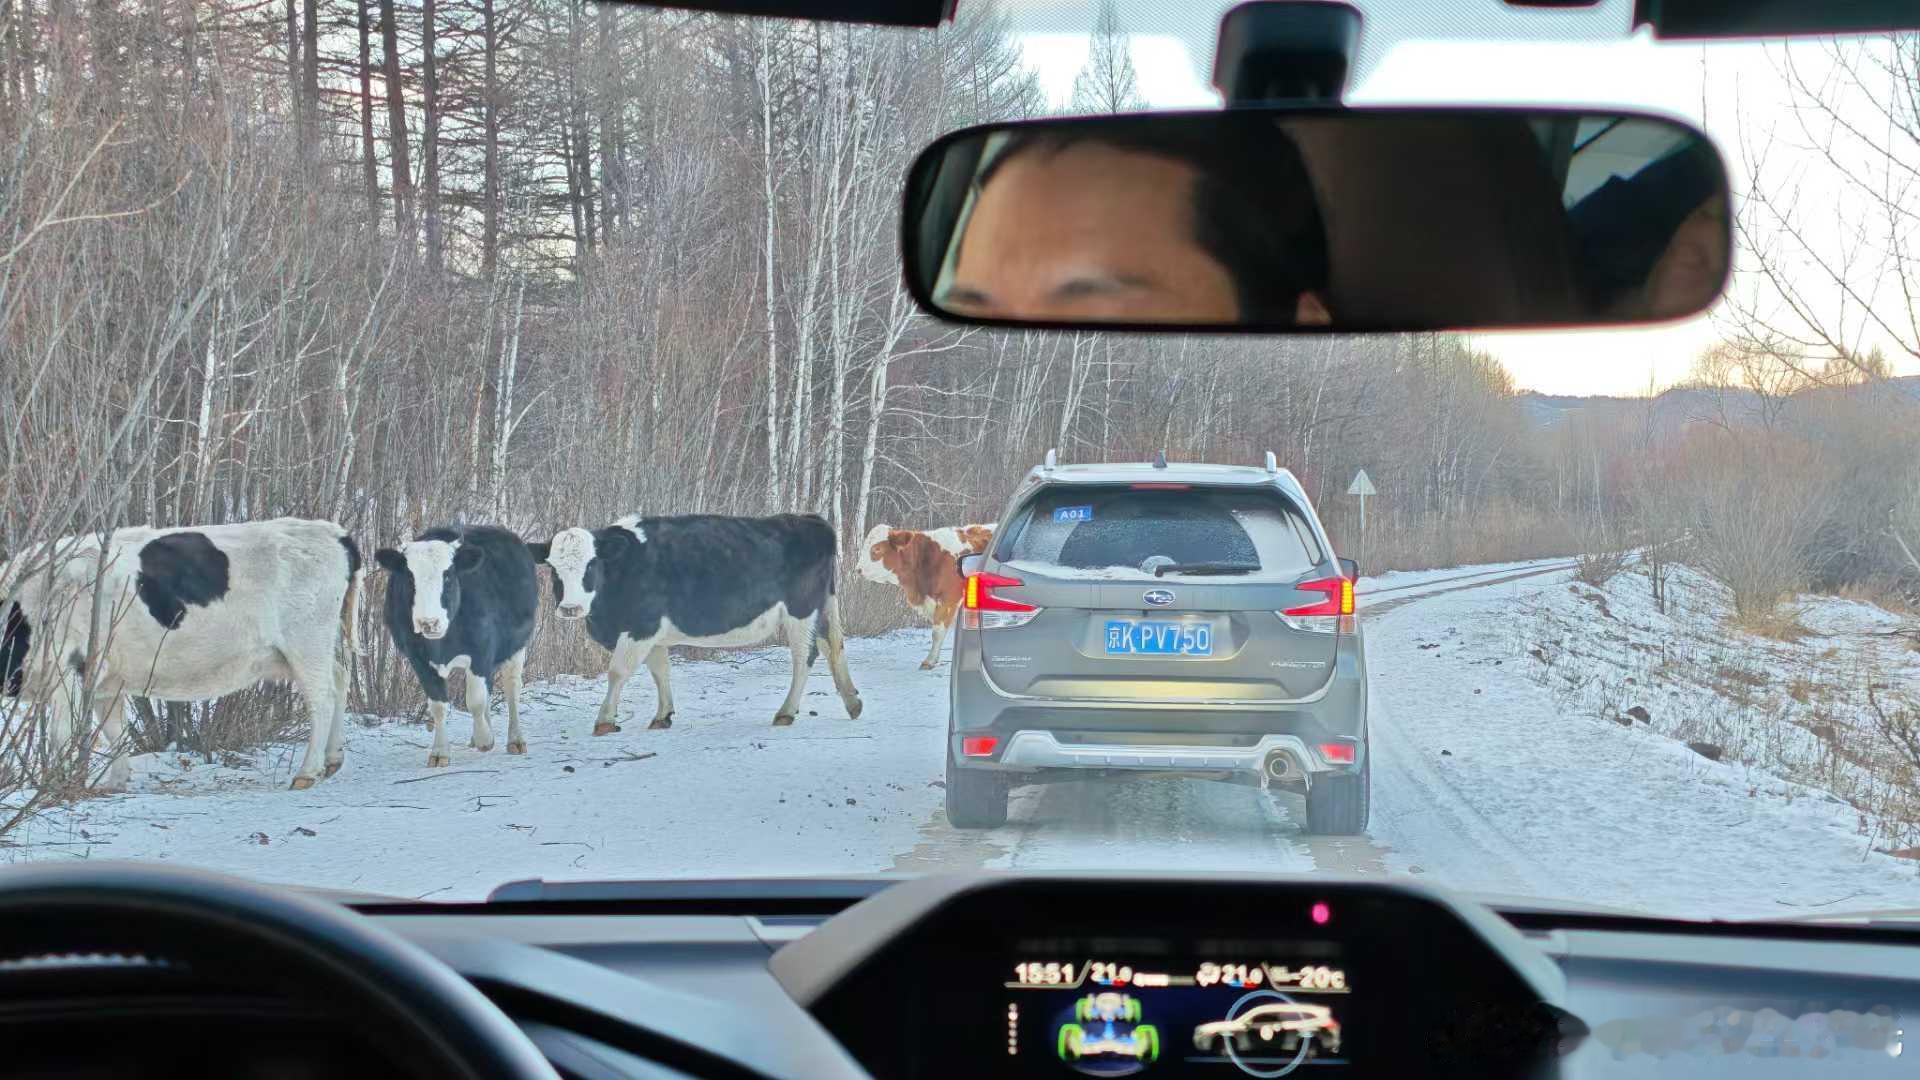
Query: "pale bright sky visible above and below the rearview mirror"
1014 0 1912 394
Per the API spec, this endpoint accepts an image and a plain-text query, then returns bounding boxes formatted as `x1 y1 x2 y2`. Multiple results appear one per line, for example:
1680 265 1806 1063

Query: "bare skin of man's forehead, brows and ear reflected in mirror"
943 142 1329 325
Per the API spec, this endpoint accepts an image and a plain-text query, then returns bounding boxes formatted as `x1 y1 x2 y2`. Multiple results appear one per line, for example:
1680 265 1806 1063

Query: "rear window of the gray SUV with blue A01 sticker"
996 486 1323 578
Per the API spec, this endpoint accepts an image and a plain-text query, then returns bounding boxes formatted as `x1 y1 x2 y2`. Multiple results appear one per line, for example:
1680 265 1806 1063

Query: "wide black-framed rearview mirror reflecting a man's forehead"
902 110 1732 332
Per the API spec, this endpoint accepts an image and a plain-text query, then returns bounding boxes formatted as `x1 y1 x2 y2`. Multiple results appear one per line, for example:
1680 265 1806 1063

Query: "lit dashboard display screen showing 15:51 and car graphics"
993 938 1367 1076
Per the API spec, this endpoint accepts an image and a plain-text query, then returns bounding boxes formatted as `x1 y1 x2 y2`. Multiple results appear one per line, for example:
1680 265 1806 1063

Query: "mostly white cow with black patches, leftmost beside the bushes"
0 517 361 790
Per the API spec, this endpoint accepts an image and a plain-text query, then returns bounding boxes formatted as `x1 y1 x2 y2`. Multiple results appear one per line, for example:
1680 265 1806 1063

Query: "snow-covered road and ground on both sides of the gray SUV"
0 559 1920 917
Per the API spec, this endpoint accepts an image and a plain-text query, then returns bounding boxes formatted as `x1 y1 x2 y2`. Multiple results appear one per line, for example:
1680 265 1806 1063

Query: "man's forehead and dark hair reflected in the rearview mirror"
937 125 1332 325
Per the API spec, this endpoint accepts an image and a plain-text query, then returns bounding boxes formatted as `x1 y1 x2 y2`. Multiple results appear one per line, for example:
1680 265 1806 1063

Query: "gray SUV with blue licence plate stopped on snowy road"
947 454 1369 834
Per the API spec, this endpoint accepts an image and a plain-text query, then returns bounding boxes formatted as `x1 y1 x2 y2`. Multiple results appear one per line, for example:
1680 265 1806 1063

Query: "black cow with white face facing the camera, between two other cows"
372 525 540 765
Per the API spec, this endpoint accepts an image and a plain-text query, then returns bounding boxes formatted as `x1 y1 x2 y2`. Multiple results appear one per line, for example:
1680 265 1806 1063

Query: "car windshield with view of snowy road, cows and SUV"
0 0 1920 919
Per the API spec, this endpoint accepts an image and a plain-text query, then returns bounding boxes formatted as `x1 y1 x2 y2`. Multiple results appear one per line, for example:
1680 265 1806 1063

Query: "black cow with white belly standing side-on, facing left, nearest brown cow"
528 513 860 734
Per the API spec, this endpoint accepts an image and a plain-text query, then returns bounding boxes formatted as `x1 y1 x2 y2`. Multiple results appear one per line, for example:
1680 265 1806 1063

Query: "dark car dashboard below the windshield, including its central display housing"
0 874 1920 1080
